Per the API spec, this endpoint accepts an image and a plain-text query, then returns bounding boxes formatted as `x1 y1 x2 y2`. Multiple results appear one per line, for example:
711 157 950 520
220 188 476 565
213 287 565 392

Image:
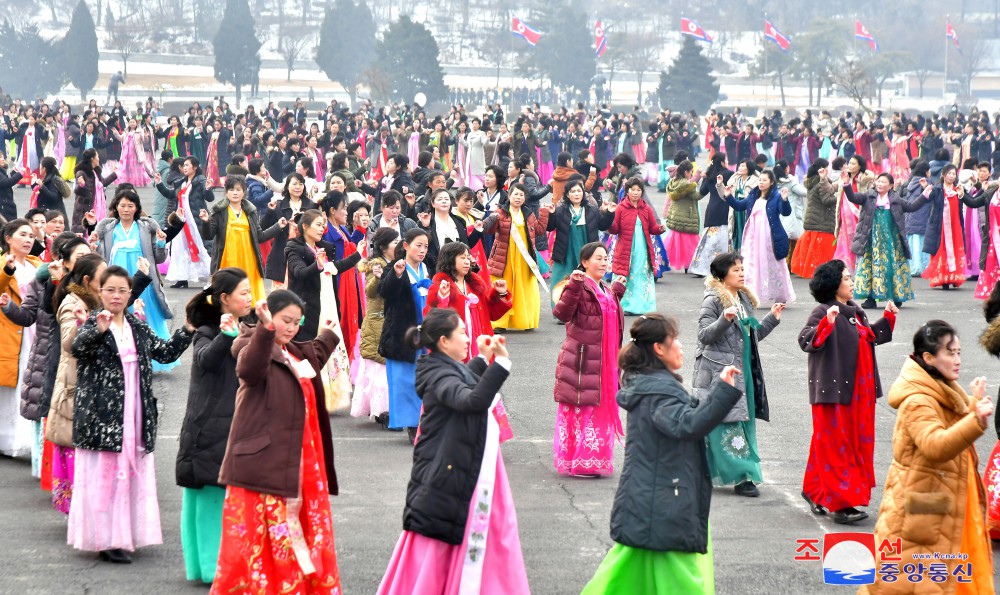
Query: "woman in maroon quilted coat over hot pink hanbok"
552 242 625 477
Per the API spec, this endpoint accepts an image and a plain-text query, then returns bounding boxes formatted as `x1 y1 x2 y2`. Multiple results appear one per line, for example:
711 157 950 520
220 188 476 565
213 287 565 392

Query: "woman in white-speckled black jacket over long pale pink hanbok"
67 266 195 564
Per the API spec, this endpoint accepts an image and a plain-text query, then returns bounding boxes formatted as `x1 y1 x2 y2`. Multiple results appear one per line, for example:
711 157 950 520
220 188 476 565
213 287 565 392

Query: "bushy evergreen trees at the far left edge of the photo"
0 19 65 99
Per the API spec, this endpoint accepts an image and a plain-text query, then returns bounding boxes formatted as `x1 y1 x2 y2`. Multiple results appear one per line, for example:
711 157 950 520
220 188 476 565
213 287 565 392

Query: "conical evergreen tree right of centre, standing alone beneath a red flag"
657 35 719 114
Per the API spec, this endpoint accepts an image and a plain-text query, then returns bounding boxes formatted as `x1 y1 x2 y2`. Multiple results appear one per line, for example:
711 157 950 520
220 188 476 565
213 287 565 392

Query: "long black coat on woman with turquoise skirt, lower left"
175 324 240 489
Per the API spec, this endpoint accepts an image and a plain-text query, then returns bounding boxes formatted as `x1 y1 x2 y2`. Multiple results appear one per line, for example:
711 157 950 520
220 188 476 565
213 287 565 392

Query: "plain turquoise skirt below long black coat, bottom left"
181 486 226 584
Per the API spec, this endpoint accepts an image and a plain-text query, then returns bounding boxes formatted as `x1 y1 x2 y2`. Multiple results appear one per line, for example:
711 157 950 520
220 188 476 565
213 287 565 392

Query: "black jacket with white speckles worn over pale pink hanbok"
72 312 194 452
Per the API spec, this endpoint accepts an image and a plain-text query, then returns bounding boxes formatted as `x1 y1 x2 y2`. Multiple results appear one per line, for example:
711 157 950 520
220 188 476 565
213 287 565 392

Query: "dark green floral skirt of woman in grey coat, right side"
854 209 913 302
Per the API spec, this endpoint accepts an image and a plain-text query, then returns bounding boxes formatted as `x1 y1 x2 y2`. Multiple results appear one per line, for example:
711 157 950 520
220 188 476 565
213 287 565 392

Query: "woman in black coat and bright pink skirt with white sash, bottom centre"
378 309 530 595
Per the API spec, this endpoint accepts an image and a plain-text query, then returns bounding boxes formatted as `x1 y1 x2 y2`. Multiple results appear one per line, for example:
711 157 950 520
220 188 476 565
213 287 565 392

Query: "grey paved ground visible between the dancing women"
0 183 1000 595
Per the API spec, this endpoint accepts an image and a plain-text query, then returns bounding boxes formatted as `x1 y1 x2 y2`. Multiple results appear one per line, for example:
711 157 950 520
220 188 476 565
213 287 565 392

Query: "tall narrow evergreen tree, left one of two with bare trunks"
212 0 261 107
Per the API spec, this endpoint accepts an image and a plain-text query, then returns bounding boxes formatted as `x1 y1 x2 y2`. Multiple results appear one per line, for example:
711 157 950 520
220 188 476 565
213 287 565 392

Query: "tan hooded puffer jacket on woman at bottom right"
858 359 989 595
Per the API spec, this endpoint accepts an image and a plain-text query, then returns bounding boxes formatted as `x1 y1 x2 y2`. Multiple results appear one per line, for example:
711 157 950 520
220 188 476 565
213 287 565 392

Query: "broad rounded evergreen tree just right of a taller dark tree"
373 15 448 102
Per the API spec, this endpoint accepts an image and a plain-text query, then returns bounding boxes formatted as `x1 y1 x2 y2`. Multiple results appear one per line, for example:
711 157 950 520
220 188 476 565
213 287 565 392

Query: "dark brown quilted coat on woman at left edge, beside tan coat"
3 265 52 421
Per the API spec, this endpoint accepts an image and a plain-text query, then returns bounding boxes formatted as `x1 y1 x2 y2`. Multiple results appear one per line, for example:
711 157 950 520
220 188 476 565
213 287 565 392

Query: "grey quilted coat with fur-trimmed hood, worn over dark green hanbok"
692 277 780 423
